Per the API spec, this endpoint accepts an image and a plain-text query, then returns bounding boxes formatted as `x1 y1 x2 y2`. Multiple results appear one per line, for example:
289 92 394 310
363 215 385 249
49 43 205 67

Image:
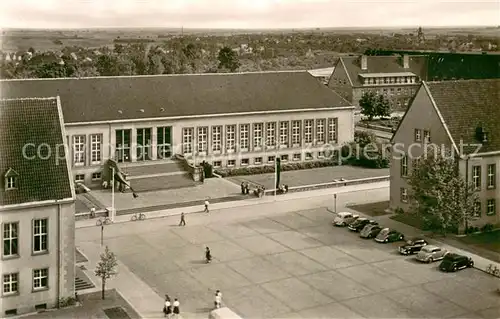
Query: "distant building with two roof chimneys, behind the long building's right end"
328 55 427 110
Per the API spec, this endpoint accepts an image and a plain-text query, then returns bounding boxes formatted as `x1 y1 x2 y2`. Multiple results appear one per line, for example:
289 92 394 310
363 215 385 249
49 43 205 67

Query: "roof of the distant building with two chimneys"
337 55 427 87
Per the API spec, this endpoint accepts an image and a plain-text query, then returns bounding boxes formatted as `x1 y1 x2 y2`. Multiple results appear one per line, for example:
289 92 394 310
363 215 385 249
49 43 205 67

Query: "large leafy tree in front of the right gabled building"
408 144 478 235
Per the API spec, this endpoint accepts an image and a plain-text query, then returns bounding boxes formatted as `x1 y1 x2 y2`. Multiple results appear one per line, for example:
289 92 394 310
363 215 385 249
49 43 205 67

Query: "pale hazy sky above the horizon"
0 0 500 28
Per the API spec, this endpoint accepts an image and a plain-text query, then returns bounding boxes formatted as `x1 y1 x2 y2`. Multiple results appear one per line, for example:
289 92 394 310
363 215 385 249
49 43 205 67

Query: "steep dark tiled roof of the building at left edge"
0 98 72 206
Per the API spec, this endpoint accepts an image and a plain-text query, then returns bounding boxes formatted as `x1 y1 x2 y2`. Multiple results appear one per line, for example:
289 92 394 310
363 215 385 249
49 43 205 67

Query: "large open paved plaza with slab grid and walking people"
77 208 500 318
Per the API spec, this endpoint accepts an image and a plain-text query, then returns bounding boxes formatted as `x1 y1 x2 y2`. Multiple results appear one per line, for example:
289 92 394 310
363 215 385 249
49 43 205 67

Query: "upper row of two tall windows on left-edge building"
2 218 49 258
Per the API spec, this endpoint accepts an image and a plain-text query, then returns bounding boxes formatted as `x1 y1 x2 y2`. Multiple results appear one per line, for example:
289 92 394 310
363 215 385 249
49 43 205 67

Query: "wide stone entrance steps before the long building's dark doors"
120 160 199 193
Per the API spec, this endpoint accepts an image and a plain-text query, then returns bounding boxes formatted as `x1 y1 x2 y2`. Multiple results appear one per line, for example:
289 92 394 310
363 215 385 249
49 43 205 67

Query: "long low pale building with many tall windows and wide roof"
0 71 354 186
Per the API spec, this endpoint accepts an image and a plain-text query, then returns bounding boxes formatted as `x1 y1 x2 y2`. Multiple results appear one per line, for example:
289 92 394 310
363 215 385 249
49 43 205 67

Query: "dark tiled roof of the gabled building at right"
425 79 500 153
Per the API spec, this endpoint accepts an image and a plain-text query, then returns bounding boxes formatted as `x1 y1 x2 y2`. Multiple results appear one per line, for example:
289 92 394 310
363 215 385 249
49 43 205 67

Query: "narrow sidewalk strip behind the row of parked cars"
347 208 500 278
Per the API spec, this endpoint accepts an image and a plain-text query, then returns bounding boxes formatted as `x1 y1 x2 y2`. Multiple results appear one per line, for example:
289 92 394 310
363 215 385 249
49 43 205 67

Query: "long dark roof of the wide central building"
0 71 350 123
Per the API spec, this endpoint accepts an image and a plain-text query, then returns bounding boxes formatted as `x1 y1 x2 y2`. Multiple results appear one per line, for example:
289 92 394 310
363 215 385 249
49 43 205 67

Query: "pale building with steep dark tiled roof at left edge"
0 98 75 317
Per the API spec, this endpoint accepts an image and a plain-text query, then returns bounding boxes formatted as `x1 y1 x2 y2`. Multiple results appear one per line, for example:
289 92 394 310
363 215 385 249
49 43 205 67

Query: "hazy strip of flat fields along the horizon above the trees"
1 27 499 52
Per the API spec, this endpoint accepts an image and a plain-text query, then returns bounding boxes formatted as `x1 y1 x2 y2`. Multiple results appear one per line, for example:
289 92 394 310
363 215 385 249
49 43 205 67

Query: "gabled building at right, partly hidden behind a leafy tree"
390 79 500 226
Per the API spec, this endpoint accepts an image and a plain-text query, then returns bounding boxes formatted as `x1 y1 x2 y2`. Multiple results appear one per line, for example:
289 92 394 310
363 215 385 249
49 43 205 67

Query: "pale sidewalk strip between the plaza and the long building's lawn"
76 181 389 228
